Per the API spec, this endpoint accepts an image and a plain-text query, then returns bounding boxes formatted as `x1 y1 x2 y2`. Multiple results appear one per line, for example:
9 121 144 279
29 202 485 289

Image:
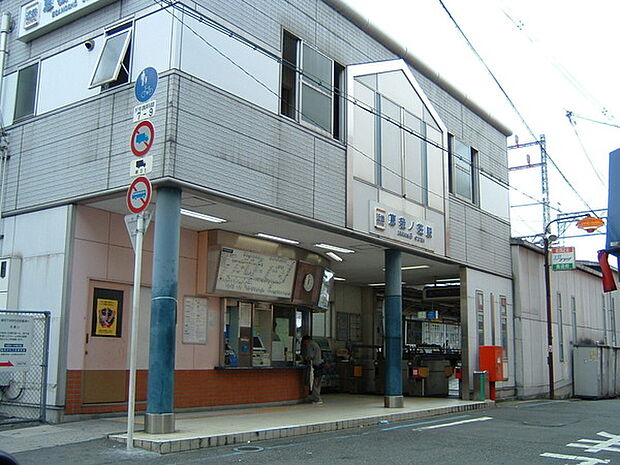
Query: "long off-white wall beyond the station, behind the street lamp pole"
512 241 618 398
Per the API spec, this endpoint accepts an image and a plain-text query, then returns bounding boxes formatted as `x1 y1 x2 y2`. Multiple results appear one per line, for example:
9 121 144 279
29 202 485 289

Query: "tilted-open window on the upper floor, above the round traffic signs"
90 24 132 88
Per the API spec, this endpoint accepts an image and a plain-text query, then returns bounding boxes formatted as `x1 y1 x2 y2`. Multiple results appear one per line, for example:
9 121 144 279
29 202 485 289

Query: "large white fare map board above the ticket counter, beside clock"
215 247 297 299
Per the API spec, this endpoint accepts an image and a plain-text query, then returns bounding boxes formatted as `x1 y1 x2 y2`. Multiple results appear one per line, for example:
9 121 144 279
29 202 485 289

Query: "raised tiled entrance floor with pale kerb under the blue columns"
108 394 494 454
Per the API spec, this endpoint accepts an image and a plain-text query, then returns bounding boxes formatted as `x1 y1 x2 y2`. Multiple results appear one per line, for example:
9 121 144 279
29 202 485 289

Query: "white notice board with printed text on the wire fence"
0 315 33 372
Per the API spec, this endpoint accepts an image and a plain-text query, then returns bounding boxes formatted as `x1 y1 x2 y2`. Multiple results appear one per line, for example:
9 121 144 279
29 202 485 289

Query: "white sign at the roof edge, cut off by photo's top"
18 0 115 42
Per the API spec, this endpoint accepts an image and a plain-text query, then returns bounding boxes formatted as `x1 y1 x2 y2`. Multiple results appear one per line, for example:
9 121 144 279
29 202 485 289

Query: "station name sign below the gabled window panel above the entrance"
370 202 435 250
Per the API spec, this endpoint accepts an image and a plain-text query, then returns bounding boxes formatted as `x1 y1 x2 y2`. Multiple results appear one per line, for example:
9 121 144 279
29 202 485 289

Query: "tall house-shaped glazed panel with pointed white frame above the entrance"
347 65 445 211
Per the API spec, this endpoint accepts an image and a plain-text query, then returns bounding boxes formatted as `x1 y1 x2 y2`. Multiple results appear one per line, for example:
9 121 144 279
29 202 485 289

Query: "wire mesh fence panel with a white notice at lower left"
0 310 50 425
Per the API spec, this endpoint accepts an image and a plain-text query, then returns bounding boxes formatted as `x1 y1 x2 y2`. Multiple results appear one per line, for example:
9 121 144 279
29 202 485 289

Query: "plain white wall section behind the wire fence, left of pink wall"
2 206 71 404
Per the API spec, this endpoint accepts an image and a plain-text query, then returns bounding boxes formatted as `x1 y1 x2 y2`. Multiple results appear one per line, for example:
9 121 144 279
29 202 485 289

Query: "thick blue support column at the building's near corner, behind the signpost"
144 187 181 434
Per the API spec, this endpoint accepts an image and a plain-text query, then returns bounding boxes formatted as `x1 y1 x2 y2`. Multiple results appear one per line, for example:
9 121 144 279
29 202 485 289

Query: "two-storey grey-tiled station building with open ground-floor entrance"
0 0 516 419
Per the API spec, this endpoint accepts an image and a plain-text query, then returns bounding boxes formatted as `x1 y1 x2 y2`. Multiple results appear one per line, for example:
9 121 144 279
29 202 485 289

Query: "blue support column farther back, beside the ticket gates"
384 249 404 408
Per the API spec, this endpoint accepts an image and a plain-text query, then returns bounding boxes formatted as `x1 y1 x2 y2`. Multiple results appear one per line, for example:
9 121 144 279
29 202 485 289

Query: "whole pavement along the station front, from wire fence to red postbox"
0 394 494 454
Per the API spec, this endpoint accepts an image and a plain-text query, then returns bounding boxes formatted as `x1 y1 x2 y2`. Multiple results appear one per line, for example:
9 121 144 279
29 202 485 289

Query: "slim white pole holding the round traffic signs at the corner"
127 213 144 450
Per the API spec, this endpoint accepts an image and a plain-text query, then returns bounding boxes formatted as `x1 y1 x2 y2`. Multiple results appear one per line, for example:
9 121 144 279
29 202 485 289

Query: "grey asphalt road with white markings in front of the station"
10 399 620 465
